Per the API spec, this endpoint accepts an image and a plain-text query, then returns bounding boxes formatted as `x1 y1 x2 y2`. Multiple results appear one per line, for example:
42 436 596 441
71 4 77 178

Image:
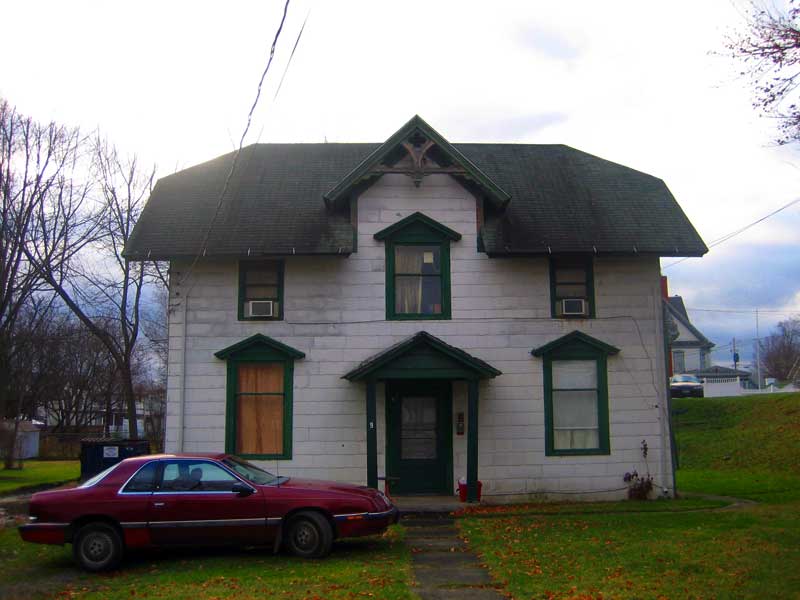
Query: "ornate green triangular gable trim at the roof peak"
323 115 511 207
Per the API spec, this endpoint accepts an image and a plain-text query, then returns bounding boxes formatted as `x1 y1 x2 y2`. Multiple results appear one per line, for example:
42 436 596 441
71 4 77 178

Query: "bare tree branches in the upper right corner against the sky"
727 0 800 144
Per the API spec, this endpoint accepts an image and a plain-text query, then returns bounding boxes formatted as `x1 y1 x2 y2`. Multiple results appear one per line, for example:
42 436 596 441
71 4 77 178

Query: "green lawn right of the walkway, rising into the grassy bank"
460 394 800 600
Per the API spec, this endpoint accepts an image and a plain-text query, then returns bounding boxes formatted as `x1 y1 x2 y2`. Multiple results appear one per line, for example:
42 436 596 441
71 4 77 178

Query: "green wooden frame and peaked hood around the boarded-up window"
214 334 305 460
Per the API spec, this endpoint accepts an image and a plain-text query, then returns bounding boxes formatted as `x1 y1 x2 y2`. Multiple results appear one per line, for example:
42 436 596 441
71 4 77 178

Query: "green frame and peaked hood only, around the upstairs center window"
374 213 461 321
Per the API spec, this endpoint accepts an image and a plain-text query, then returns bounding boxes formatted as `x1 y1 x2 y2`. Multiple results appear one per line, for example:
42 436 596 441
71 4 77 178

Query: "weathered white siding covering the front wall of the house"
167 175 671 500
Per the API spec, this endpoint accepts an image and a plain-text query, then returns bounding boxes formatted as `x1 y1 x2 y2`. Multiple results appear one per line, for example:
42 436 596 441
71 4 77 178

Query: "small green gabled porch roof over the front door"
342 331 501 381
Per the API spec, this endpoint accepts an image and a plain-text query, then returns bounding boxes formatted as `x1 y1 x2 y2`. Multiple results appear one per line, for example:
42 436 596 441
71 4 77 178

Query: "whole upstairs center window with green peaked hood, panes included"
375 213 461 320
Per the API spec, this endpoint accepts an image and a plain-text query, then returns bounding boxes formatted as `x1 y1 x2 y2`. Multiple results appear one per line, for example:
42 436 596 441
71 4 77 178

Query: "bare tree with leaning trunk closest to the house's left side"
25 137 155 438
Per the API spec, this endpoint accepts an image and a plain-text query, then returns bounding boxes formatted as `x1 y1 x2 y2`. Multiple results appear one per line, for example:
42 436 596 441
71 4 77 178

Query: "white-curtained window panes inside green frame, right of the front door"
552 360 600 450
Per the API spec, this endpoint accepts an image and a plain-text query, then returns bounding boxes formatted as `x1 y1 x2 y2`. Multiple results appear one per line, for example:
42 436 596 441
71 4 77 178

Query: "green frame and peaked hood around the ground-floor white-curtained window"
533 332 619 456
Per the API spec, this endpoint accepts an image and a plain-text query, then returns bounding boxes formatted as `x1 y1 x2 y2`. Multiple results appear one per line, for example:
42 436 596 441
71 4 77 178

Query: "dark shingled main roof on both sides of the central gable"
125 144 708 259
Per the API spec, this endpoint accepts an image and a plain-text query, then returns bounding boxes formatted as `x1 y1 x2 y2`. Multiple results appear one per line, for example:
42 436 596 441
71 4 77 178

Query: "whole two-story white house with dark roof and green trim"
125 117 707 500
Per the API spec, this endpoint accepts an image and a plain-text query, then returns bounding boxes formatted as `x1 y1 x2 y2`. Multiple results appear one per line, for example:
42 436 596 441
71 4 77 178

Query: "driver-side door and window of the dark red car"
148 458 268 545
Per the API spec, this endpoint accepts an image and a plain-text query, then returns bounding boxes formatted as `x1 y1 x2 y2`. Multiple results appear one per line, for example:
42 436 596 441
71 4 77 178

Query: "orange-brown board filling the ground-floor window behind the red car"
236 362 285 454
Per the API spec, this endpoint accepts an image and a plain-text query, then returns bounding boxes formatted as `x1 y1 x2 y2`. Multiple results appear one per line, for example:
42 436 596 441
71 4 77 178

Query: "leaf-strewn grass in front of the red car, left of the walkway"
0 526 414 600
